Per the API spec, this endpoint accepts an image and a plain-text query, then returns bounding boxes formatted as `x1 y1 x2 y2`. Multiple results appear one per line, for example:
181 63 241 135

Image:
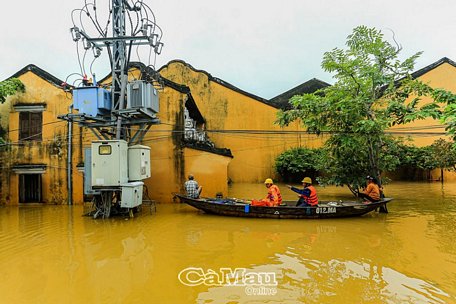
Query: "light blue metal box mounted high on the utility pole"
73 87 111 117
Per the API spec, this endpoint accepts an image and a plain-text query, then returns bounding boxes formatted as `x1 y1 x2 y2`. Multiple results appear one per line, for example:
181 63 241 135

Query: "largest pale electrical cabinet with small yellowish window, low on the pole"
92 140 128 187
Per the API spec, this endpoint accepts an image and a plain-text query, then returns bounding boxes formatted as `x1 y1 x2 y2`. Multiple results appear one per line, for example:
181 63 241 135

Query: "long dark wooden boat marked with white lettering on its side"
176 194 392 219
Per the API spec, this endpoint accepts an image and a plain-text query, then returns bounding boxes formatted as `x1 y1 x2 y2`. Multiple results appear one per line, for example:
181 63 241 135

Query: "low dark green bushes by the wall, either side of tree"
275 138 456 185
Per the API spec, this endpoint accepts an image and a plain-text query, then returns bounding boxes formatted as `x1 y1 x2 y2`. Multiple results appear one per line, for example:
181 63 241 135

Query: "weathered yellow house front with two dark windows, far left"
0 65 82 204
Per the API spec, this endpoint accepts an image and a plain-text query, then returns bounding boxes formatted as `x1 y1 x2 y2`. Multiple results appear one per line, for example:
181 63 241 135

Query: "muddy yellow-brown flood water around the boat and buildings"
0 183 456 304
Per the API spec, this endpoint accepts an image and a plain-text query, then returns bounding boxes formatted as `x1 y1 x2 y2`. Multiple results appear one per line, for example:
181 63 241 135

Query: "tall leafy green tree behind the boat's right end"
277 26 456 197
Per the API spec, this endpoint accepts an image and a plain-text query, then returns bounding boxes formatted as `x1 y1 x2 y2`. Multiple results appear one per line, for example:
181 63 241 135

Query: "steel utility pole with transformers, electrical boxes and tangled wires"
59 0 163 218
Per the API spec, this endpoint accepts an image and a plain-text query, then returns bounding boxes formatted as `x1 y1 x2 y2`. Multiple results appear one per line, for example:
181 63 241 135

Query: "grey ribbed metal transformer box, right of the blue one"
127 80 160 113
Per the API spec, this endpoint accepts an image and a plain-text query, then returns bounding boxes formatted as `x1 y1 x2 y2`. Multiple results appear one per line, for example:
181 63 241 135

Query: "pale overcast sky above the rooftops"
0 0 456 98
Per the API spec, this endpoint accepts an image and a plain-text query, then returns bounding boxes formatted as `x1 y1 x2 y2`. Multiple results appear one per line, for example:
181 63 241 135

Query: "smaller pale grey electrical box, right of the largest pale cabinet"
128 145 150 181
